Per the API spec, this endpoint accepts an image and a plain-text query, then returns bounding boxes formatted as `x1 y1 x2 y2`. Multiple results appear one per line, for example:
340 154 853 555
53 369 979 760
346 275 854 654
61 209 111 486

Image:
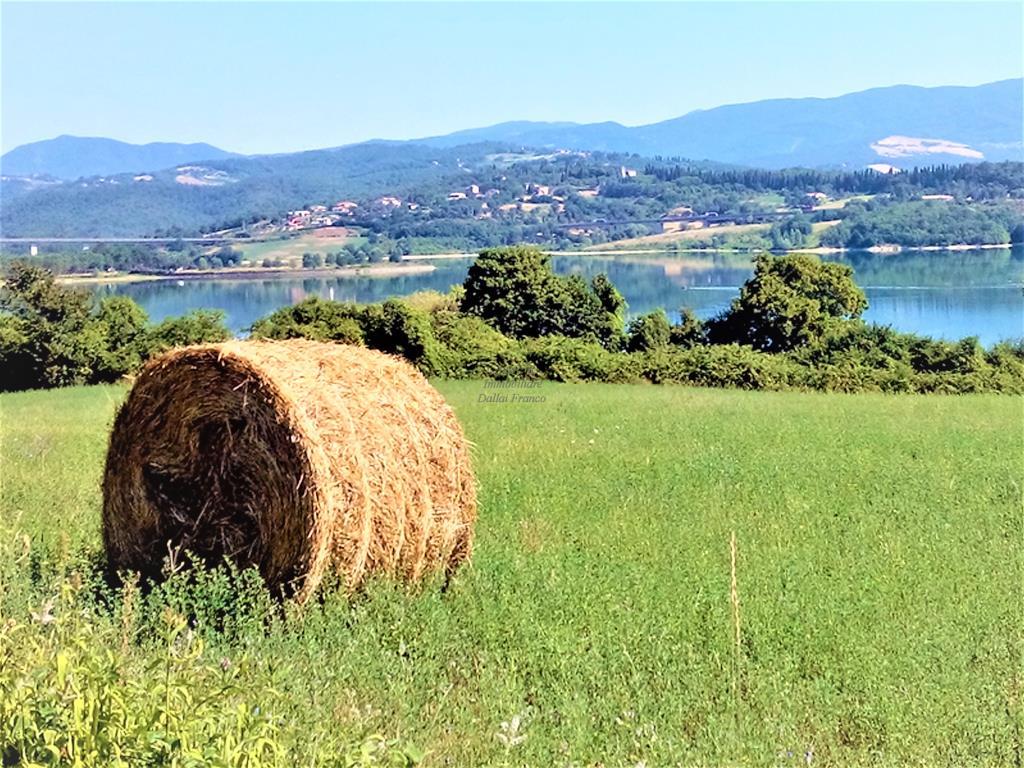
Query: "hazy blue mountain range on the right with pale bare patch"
421 79 1024 168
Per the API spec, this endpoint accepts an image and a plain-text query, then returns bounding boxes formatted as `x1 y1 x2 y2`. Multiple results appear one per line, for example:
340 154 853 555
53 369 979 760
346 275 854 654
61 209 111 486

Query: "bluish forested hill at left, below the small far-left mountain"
0 142 524 237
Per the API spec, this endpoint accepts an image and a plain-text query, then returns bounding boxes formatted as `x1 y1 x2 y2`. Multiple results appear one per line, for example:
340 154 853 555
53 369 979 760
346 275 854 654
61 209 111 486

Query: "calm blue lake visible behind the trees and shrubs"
93 248 1024 344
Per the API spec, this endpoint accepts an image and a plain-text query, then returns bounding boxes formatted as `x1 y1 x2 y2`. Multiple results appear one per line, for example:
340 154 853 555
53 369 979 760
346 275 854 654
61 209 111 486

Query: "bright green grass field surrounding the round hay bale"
0 382 1024 767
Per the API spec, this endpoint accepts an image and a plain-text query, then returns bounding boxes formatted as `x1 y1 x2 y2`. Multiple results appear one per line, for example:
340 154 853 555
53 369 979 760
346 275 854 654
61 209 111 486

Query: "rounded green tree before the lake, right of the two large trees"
709 254 867 352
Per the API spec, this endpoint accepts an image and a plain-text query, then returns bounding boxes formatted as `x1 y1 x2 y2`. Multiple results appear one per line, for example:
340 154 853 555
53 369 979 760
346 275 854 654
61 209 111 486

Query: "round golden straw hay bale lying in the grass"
103 340 476 599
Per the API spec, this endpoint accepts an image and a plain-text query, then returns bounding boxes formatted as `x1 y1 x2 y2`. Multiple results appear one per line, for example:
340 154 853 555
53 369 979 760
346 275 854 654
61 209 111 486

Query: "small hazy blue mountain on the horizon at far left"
0 136 239 180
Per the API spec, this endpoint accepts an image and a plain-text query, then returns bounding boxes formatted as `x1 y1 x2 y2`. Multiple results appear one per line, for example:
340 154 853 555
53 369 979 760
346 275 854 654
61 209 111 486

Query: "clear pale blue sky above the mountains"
0 2 1024 153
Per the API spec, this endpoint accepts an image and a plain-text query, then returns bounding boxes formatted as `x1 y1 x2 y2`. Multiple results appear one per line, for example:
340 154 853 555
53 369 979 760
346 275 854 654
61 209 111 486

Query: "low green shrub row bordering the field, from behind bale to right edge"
252 294 1024 394
